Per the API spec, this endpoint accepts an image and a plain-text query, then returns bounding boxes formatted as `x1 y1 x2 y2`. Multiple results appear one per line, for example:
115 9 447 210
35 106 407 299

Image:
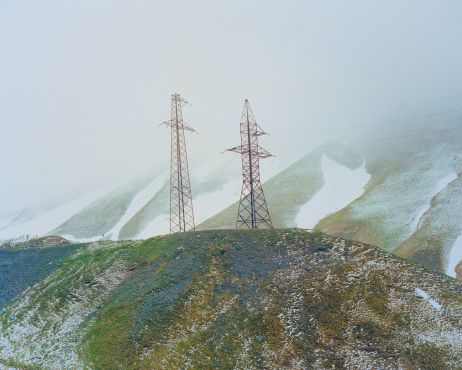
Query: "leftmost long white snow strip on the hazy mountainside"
0 186 121 239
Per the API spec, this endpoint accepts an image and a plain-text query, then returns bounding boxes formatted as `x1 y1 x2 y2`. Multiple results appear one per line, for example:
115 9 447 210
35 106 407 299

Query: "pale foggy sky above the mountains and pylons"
0 0 462 215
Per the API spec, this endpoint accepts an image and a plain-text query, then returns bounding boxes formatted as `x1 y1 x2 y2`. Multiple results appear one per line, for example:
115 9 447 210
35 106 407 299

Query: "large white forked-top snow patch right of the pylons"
295 155 371 229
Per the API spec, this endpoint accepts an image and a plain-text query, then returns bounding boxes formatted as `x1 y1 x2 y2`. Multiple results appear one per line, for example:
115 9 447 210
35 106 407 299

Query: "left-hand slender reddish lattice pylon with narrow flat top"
164 94 195 233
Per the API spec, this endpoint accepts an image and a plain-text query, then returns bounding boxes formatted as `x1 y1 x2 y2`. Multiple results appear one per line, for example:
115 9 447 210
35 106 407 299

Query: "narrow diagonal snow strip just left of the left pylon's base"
106 172 168 240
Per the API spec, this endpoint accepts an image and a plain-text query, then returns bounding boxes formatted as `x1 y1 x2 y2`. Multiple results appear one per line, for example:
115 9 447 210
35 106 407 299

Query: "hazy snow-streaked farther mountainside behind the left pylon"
0 157 245 242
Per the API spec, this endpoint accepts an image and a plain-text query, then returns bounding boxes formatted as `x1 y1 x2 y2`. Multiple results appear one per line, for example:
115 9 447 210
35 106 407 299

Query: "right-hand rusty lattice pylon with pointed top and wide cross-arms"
227 99 273 229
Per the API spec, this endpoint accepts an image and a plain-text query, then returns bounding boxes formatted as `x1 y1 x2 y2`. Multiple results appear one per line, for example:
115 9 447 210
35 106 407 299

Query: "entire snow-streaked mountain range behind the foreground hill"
0 116 462 276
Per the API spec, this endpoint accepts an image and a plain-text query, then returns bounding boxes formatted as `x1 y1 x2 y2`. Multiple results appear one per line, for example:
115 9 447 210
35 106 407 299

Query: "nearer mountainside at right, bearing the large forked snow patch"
199 127 462 276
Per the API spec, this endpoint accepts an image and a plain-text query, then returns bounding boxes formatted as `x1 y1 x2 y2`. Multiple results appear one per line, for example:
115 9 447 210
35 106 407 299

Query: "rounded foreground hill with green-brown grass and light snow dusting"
0 230 462 369
